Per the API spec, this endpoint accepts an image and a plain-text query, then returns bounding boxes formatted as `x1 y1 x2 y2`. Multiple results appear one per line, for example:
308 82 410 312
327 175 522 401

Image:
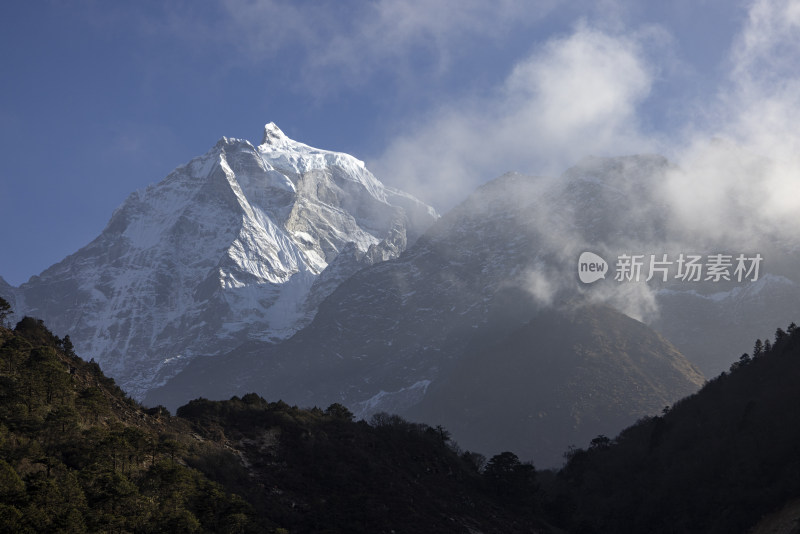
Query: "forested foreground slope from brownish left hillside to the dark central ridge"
0 318 557 534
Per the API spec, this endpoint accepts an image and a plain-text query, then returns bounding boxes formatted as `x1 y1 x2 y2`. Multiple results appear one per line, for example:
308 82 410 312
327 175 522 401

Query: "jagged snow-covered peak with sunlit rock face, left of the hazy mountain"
3 123 437 396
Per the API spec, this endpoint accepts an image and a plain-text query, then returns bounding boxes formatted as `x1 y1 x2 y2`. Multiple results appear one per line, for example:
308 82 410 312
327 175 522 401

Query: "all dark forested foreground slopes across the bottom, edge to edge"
0 296 800 533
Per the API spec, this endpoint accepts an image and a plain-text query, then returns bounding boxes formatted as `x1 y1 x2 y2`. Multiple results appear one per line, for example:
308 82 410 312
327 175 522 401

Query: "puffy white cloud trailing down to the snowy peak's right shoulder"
370 23 654 208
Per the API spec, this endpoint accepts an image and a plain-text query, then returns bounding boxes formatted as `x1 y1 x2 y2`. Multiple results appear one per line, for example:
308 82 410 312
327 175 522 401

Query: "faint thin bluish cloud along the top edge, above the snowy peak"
216 0 560 87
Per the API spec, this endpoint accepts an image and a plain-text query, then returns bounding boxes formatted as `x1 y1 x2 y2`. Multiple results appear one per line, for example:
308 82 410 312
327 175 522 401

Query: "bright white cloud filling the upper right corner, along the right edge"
665 0 800 246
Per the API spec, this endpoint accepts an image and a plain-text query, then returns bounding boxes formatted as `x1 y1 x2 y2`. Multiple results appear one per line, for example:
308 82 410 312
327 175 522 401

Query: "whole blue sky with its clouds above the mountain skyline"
6 0 800 285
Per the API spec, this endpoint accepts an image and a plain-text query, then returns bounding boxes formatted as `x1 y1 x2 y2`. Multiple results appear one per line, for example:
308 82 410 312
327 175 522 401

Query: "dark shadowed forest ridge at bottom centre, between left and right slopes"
178 394 553 533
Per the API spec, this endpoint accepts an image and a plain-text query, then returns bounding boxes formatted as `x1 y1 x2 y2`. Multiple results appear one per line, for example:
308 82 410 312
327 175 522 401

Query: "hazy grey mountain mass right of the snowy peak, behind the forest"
142 156 798 465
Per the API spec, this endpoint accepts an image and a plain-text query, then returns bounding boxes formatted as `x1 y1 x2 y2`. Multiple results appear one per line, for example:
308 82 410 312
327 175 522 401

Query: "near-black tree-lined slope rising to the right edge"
554 325 800 533
